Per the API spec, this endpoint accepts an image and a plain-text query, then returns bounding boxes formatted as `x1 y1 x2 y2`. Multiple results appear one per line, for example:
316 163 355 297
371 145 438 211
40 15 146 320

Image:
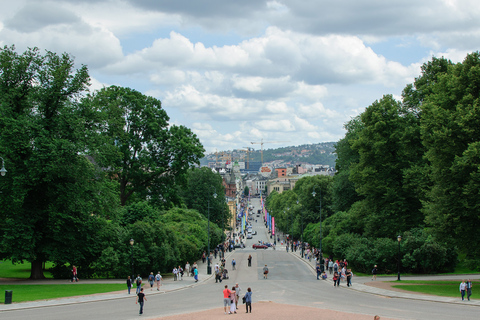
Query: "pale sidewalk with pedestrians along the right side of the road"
289 250 480 307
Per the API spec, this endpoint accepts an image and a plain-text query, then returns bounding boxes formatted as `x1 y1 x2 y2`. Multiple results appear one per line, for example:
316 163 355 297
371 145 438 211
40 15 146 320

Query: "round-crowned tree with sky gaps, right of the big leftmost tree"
83 86 204 207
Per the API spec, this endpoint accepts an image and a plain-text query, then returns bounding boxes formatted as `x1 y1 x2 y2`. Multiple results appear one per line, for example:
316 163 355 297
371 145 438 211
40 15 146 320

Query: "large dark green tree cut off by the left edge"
0 47 114 279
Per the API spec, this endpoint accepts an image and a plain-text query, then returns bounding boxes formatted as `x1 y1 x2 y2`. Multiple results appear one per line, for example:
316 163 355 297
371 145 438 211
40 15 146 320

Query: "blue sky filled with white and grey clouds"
0 0 480 152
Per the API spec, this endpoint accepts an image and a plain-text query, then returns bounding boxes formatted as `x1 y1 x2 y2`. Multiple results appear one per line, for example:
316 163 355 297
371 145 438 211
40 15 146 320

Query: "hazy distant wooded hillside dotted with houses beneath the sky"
201 142 337 167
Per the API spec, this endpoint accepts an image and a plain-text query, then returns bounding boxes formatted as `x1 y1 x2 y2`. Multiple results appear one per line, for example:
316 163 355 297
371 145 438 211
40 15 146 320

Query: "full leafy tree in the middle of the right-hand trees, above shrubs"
350 96 424 237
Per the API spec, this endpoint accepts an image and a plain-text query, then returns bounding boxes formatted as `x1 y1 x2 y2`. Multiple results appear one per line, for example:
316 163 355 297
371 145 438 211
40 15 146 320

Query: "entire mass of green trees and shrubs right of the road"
267 52 480 273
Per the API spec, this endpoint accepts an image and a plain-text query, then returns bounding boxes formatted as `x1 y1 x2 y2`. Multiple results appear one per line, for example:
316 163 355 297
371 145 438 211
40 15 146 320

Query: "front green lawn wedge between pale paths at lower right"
391 280 480 299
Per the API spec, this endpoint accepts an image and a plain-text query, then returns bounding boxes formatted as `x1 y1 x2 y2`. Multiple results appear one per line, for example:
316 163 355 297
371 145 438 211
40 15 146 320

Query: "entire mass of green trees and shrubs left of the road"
0 46 228 279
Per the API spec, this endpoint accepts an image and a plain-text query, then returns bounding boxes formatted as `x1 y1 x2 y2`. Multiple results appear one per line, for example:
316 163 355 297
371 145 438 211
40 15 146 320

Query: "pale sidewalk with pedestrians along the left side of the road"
0 252 227 312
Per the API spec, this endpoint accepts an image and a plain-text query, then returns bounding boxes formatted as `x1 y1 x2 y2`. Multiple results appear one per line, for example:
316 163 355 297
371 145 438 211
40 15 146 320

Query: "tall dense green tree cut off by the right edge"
421 52 480 259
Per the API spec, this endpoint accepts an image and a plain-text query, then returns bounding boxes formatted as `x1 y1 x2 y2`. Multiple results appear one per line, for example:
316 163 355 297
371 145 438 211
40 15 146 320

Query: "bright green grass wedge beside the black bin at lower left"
0 283 127 303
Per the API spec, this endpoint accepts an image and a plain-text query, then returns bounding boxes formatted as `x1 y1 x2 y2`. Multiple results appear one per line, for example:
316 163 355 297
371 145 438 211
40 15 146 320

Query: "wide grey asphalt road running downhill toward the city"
0 199 480 320
